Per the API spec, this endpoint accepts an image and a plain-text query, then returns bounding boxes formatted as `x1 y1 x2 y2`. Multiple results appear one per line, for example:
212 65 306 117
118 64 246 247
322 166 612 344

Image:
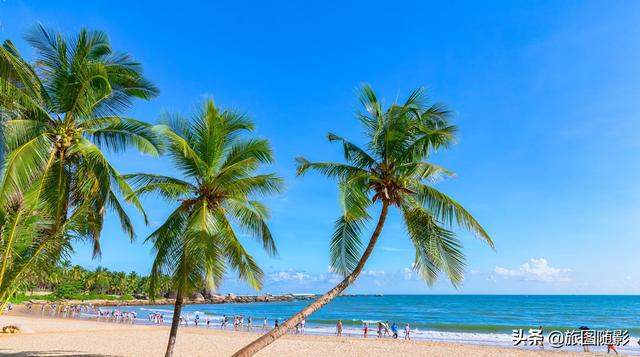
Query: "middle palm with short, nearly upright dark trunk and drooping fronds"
128 100 282 356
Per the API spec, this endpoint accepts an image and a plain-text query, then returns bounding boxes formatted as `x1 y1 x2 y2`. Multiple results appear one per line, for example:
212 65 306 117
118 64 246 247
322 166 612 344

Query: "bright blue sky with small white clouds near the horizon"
0 0 640 294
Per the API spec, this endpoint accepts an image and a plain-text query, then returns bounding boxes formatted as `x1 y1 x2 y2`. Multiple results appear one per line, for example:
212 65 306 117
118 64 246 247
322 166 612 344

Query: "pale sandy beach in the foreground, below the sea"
0 314 602 357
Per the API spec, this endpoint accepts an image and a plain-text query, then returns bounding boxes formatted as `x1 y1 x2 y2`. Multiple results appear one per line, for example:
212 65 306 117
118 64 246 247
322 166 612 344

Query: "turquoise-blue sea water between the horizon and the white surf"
131 295 640 335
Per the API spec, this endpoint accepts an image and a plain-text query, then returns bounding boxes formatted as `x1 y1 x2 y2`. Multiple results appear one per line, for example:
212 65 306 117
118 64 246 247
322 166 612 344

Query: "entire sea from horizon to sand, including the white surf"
97 295 640 354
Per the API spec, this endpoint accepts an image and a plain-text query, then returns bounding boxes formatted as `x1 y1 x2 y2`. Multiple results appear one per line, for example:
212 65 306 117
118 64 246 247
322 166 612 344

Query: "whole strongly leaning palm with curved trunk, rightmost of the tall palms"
234 86 493 356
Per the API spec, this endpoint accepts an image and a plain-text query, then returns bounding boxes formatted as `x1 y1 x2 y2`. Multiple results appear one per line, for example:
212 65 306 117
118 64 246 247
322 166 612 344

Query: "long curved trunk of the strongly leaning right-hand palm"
232 202 389 357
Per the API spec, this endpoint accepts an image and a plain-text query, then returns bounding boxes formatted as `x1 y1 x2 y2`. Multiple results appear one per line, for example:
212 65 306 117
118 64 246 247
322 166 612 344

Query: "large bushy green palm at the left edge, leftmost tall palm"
0 25 159 301
